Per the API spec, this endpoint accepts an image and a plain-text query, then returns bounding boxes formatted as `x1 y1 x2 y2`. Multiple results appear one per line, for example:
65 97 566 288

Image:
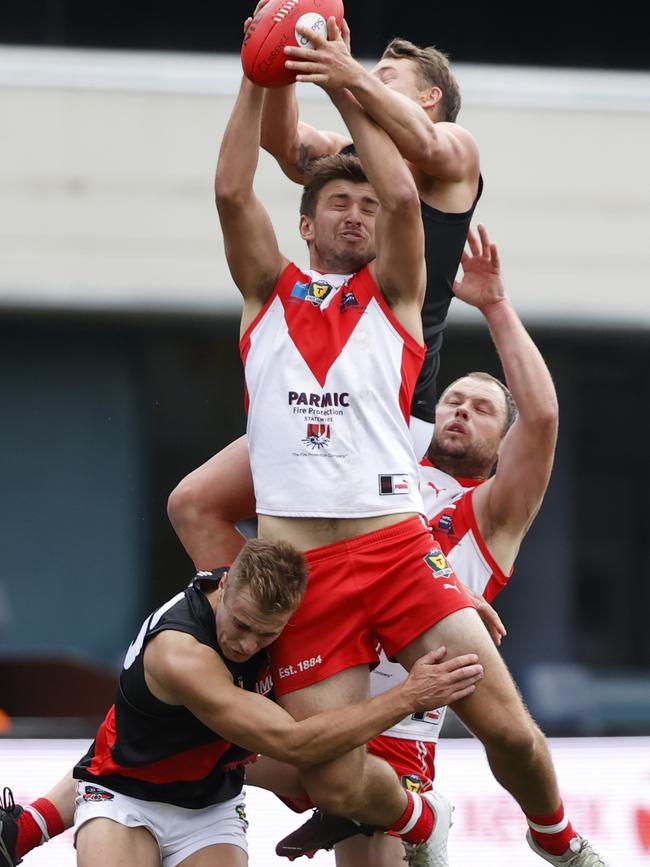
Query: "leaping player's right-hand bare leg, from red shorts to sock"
397 608 560 815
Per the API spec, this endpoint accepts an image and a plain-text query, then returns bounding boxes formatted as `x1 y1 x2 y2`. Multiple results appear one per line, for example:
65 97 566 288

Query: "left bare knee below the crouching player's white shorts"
75 818 160 867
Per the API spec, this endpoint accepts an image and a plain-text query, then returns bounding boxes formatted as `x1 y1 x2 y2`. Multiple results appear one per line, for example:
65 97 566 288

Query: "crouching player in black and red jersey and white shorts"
68 539 482 867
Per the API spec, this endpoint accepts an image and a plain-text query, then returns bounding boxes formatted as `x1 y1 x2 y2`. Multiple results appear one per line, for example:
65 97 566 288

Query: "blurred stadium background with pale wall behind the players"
0 0 650 864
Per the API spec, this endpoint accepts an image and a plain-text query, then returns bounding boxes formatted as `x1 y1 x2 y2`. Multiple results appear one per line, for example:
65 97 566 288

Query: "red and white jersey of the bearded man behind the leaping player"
370 458 512 742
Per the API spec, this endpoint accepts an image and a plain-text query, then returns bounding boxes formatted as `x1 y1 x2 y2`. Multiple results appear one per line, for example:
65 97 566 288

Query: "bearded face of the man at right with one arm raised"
429 376 507 477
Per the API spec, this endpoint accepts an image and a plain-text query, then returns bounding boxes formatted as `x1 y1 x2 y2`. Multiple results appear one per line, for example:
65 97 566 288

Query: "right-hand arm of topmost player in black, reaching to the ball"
285 18 479 182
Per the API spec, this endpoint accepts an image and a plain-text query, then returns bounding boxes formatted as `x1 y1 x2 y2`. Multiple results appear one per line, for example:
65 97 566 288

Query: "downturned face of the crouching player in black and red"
215 575 293 662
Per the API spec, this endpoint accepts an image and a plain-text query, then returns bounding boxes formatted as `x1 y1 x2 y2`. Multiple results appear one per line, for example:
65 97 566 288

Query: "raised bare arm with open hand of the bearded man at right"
454 226 558 559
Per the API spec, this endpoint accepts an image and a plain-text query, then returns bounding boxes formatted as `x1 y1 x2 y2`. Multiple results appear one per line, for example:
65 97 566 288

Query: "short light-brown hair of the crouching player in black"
228 539 307 614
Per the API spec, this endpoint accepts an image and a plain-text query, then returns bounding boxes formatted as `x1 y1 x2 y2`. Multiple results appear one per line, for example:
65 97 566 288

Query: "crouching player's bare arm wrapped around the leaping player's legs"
145 631 483 766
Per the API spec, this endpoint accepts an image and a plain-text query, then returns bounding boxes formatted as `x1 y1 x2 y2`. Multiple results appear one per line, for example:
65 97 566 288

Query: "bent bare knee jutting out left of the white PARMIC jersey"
167 436 255 569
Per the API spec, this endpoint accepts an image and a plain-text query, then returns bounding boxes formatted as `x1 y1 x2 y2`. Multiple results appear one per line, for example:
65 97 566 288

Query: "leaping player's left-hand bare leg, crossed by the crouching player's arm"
279 665 407 828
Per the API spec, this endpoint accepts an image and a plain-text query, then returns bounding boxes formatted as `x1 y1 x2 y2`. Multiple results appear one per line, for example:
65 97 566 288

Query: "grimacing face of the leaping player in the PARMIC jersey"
300 179 379 274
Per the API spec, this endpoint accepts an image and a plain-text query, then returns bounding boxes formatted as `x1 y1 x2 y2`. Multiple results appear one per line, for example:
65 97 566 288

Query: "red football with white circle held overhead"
241 0 343 87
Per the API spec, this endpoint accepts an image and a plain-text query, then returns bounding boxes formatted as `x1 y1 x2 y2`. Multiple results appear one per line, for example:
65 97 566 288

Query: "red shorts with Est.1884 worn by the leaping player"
269 518 473 696
